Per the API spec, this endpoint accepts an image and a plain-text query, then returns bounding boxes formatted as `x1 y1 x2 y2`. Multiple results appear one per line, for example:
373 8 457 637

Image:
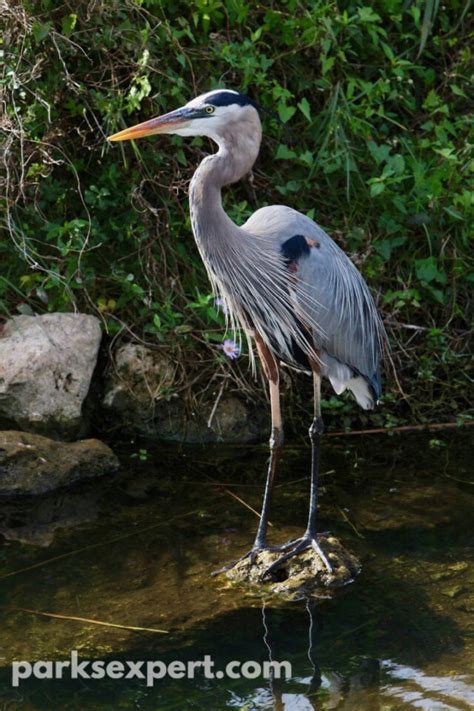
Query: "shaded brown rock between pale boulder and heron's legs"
102 343 266 443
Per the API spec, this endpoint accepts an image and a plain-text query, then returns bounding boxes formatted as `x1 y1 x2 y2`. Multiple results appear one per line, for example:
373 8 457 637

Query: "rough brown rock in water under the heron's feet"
226 536 361 599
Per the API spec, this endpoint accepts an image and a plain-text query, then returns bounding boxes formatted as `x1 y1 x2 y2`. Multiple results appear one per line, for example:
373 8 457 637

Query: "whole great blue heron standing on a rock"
109 89 384 575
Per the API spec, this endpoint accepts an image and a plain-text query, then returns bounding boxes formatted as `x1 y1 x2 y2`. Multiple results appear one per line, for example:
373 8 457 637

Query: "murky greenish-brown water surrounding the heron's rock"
0 433 474 711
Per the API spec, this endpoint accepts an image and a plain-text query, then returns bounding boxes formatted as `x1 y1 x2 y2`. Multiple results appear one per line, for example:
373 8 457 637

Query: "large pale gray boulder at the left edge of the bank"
0 313 102 439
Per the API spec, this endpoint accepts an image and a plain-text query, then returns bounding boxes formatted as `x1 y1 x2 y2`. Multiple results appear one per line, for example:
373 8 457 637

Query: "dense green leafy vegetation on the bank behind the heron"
0 0 473 426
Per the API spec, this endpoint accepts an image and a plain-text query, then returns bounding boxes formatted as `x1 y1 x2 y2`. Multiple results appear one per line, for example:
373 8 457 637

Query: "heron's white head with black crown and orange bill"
108 89 260 144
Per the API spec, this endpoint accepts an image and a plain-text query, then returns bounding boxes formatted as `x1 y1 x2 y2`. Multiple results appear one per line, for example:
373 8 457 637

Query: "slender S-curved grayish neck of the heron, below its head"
189 119 261 253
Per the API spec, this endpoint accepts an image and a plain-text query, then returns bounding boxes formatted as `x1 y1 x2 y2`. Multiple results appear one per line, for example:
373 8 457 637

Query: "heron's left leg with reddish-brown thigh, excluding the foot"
253 334 284 550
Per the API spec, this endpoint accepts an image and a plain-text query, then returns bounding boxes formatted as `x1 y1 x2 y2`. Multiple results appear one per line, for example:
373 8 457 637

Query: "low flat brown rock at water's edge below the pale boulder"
0 430 119 495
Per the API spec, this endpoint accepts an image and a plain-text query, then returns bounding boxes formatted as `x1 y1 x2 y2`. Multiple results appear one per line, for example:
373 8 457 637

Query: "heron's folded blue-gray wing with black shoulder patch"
243 205 385 400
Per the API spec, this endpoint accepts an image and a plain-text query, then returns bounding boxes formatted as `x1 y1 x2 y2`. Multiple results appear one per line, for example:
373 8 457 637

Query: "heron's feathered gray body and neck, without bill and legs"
183 92 382 409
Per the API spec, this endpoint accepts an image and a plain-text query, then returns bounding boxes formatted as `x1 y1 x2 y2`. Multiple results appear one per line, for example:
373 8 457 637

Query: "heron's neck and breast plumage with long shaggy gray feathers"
189 109 313 364
